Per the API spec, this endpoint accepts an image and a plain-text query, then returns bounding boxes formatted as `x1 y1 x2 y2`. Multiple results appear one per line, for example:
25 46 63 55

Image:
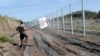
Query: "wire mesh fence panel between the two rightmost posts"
71 0 83 35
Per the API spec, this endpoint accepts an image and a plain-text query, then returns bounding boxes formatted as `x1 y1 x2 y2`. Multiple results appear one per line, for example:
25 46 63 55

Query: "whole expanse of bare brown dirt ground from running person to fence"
9 29 100 56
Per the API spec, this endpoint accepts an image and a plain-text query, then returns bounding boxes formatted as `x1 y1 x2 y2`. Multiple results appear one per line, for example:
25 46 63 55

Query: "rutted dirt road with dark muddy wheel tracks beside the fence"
30 30 100 56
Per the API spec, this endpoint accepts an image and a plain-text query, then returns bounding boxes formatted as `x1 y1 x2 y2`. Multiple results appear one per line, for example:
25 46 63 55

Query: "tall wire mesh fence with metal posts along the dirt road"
34 0 100 36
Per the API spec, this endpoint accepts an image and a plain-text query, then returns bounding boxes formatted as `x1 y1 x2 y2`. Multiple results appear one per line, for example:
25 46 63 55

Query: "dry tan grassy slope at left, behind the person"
0 15 18 35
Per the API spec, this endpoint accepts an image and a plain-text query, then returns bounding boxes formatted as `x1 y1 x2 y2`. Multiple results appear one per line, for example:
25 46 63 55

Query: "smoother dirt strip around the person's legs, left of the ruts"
13 30 43 56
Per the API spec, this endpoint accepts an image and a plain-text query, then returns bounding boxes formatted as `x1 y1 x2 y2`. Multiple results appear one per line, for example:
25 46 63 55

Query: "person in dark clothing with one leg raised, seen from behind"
16 21 28 48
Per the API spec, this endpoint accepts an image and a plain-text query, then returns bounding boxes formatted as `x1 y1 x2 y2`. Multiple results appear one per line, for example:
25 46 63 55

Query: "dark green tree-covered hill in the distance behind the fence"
54 10 100 21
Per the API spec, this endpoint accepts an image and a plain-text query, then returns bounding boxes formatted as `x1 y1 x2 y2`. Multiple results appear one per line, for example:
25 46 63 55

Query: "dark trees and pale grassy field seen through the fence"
54 10 100 32
